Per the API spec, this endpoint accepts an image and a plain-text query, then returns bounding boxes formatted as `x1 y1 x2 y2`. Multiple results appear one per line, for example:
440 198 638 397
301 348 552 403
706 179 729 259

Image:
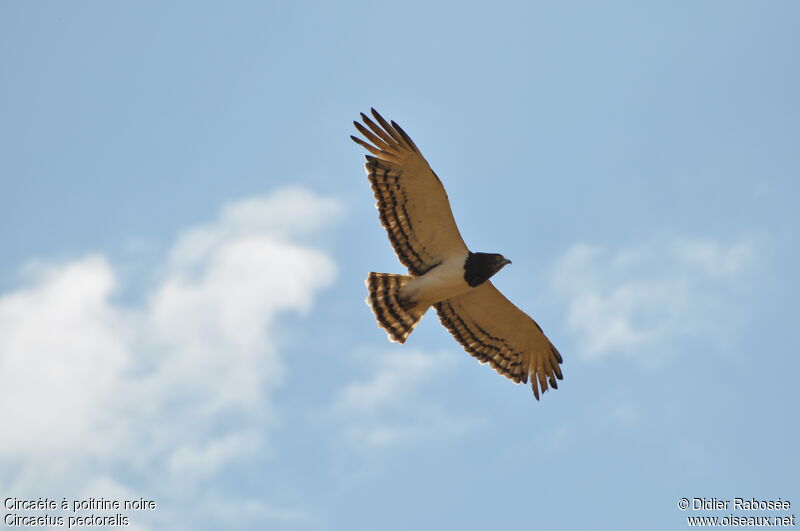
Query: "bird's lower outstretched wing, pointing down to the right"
434 281 563 400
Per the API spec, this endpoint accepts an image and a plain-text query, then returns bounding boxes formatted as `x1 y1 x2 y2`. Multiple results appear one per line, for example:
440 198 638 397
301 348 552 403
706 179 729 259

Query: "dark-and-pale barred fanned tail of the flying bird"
366 273 428 343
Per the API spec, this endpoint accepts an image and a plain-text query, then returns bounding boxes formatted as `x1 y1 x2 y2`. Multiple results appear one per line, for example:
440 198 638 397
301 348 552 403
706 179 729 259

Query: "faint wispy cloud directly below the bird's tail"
329 349 476 450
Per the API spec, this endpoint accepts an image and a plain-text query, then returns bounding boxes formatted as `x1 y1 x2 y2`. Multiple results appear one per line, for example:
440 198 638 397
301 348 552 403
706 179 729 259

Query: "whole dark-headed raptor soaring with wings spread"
350 109 563 400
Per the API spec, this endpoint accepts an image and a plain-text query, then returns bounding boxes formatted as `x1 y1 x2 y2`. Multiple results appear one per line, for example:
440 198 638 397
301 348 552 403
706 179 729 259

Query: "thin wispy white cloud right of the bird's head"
552 239 755 361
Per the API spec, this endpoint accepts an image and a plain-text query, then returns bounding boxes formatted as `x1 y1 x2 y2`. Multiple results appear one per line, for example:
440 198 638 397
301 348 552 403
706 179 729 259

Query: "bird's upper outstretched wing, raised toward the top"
350 109 467 276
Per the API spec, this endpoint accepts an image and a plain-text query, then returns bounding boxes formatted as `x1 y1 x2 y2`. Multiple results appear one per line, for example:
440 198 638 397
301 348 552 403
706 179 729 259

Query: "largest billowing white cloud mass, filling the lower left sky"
0 189 340 528
